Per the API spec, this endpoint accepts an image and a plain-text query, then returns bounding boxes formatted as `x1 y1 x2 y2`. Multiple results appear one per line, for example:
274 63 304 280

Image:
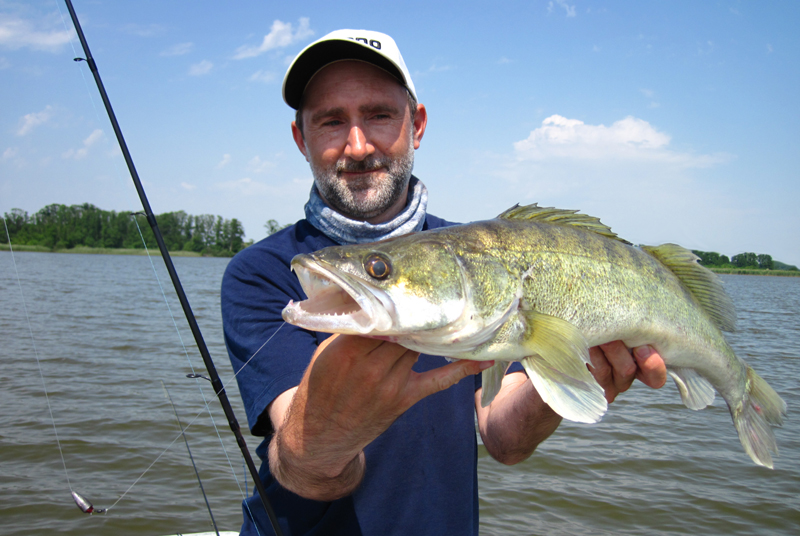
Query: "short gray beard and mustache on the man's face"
311 144 414 220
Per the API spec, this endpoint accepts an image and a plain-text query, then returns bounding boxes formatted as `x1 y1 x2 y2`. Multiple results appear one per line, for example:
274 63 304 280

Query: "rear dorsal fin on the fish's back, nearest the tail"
641 244 736 331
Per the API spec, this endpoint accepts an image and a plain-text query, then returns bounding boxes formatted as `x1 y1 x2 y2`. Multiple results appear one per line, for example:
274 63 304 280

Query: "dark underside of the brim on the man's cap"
283 39 407 110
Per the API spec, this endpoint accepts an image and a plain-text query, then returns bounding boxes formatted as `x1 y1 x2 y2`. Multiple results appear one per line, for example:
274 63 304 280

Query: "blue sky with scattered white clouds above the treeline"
0 0 800 266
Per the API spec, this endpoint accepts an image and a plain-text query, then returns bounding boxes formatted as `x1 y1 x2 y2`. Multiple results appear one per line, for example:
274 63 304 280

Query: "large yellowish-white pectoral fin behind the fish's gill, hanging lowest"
522 311 608 423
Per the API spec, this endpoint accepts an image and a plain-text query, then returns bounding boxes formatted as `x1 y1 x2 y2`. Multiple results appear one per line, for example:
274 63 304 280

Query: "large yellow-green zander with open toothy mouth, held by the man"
283 204 786 467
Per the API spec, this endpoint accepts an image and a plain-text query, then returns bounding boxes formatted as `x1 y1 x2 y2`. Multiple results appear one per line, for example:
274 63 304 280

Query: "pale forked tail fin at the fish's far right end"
731 367 786 469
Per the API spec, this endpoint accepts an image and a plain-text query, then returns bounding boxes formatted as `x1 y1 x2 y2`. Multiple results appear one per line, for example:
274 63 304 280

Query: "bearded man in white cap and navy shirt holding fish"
222 30 666 535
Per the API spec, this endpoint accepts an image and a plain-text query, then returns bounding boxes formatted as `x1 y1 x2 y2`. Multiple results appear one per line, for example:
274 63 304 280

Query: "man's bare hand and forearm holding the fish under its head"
269 335 493 501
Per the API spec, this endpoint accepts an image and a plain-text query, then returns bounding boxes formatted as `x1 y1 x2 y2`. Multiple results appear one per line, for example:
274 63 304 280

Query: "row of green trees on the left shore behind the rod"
0 203 246 256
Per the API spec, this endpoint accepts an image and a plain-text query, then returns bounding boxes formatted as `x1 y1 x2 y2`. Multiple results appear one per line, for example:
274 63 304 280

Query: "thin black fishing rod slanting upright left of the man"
64 0 283 536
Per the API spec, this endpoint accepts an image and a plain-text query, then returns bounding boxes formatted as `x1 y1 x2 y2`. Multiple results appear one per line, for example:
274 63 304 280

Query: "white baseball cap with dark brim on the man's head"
283 30 418 110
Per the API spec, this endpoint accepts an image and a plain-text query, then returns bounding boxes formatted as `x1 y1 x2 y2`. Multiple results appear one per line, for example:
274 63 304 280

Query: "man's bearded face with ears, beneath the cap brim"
292 61 427 223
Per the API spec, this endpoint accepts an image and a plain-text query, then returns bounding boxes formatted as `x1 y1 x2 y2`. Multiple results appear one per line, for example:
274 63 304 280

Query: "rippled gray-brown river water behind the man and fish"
0 252 800 536
